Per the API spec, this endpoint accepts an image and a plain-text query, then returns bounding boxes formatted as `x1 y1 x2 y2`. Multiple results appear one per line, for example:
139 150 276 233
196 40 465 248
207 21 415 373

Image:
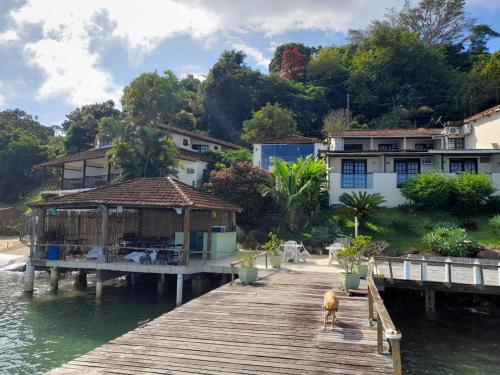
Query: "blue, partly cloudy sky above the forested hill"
0 0 500 126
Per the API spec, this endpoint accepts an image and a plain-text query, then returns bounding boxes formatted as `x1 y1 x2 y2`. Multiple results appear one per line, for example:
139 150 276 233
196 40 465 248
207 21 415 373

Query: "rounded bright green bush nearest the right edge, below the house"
452 173 495 210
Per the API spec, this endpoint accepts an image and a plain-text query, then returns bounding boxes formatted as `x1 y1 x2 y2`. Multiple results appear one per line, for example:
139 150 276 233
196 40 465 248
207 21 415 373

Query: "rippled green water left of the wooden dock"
0 272 174 375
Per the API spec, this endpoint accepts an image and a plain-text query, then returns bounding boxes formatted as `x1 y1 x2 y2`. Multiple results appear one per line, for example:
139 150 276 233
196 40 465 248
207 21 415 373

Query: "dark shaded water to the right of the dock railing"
384 291 500 375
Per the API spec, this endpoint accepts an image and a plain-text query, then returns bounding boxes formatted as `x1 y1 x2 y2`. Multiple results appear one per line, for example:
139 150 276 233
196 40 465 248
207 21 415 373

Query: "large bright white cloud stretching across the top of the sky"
0 0 401 105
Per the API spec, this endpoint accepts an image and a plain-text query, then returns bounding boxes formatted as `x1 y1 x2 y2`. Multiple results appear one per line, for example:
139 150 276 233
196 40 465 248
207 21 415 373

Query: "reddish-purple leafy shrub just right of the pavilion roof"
203 162 274 224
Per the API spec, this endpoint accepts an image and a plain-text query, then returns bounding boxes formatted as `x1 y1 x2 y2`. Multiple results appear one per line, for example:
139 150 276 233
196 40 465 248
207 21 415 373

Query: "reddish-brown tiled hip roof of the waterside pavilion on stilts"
32 177 241 211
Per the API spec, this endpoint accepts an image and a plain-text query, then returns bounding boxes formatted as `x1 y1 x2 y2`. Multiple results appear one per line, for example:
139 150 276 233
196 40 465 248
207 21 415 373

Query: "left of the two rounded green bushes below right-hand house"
401 172 452 208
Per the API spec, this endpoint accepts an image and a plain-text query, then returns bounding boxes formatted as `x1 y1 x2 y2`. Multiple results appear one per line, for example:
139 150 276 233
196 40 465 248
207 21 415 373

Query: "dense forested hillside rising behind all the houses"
0 0 500 201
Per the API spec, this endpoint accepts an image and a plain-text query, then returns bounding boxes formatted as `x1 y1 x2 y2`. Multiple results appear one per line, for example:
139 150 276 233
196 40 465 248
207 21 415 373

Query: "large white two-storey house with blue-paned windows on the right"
322 105 500 207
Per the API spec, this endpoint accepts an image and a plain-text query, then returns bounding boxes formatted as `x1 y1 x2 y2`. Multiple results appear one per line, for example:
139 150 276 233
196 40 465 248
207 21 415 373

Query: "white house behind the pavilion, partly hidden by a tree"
35 125 241 195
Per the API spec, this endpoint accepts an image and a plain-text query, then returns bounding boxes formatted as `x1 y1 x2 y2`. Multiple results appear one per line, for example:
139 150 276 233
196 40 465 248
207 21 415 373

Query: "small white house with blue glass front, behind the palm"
253 135 327 170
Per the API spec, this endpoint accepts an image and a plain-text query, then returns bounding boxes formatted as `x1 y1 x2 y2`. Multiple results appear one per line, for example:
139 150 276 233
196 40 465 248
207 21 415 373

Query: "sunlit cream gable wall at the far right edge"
465 112 500 149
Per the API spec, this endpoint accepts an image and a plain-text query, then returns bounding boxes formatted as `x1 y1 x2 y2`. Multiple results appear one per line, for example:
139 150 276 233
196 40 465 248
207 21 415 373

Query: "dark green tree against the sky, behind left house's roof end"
62 100 120 154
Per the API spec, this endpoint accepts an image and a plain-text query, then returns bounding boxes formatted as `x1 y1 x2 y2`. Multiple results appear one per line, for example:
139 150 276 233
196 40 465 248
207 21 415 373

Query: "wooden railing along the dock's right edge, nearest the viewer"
366 259 402 375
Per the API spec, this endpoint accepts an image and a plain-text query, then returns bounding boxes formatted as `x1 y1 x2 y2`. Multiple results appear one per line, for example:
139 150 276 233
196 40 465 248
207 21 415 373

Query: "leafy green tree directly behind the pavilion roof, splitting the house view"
107 125 179 180
